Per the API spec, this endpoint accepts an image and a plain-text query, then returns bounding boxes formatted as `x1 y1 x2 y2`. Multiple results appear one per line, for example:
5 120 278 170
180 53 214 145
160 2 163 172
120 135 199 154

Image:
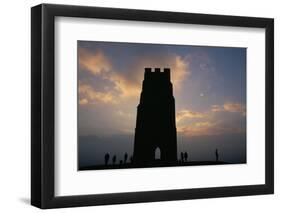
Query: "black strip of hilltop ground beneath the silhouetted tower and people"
79 161 229 171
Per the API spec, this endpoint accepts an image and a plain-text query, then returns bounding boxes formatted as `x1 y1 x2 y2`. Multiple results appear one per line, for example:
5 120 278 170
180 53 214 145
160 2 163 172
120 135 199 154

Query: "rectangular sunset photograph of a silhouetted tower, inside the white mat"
77 40 247 171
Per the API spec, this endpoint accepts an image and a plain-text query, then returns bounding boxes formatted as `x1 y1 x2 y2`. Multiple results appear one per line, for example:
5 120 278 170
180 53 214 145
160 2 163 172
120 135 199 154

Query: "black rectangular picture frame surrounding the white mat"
31 4 274 209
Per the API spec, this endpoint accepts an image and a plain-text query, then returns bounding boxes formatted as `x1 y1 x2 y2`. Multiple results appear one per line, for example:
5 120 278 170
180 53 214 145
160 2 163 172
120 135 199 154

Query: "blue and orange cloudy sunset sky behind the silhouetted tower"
77 41 246 168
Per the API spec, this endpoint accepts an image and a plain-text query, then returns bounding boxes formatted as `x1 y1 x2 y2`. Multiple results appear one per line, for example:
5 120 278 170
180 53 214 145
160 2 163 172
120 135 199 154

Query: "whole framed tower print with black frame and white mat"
31 4 274 208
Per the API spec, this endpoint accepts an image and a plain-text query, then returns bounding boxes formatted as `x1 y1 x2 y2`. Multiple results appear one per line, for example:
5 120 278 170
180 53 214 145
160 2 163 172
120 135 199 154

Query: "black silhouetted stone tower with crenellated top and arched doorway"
133 68 177 166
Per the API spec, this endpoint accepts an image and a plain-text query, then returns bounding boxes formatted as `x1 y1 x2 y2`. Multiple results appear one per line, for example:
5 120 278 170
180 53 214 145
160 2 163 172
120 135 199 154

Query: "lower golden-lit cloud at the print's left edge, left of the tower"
78 82 116 105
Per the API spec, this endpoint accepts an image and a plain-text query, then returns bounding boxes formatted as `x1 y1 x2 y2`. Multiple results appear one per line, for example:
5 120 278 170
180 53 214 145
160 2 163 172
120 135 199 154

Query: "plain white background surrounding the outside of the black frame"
0 0 281 213
